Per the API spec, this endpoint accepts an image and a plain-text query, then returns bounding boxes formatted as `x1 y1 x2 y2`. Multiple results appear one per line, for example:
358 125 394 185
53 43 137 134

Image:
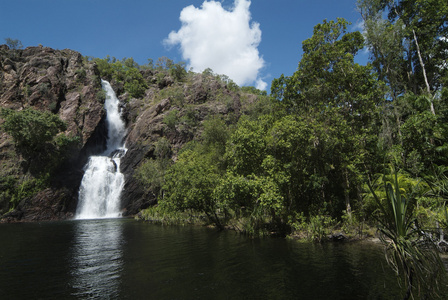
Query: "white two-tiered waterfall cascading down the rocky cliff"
75 80 126 219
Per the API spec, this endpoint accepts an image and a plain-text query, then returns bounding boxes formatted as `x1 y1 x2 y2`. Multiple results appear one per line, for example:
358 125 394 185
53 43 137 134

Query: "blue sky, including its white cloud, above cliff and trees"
0 0 366 90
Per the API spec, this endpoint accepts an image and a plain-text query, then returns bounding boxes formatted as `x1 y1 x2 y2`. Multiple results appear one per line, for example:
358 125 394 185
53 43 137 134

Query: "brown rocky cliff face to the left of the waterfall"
0 45 105 220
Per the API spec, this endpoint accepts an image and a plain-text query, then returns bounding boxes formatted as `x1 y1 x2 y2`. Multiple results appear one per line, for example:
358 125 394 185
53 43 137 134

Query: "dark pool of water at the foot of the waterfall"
0 219 399 299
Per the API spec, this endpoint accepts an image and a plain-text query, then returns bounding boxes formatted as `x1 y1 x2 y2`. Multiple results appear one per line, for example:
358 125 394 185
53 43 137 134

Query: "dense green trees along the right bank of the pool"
137 0 448 248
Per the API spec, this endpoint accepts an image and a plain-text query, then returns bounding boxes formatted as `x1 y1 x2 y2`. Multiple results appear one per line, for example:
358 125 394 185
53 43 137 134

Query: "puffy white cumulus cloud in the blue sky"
164 0 267 88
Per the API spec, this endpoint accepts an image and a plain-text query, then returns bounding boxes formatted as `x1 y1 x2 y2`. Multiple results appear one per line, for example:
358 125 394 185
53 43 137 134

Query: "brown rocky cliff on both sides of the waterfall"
0 45 255 221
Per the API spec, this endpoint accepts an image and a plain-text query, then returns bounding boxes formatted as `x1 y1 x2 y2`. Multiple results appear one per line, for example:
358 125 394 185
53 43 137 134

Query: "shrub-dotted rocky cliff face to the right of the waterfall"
121 73 241 215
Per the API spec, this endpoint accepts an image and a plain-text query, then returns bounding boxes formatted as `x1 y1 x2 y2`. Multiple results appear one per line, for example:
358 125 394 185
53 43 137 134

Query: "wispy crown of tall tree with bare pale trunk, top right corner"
358 0 448 114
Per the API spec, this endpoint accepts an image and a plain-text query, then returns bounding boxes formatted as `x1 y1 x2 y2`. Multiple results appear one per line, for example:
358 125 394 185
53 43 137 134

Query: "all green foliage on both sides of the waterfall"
0 0 448 298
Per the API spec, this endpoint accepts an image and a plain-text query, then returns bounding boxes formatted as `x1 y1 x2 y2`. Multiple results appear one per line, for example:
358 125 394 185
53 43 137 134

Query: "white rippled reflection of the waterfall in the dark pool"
70 219 123 299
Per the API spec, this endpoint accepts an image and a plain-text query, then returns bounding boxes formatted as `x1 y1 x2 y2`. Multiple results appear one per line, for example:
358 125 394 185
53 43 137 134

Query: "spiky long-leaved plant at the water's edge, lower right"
369 170 446 299
